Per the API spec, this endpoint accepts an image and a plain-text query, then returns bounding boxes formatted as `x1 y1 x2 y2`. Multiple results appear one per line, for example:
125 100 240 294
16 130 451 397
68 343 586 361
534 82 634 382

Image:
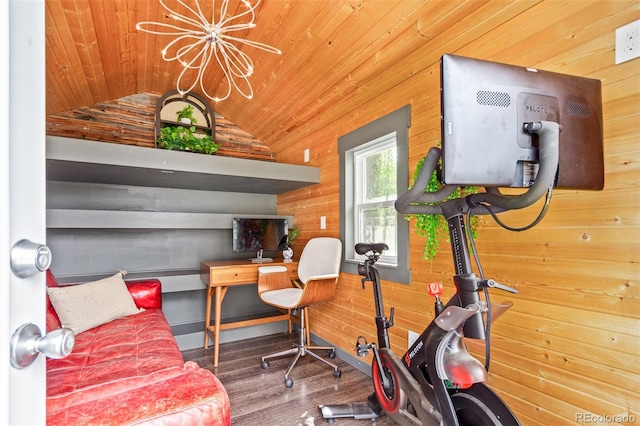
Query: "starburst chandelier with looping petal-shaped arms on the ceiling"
136 0 281 102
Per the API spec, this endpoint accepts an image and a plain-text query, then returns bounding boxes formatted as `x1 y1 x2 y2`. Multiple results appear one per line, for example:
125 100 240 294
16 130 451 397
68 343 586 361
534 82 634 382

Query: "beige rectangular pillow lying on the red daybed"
47 272 144 333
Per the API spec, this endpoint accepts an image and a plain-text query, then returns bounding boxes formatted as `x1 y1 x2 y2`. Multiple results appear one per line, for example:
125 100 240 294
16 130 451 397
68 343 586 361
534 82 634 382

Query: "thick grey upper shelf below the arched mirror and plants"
47 136 320 194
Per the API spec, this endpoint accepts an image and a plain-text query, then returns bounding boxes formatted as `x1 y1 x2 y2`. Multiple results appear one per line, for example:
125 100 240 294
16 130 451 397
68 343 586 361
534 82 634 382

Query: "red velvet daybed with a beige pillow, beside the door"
47 271 231 426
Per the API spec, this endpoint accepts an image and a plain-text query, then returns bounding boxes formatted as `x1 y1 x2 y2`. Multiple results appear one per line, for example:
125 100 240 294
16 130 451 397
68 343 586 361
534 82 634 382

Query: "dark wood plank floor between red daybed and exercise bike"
182 332 395 426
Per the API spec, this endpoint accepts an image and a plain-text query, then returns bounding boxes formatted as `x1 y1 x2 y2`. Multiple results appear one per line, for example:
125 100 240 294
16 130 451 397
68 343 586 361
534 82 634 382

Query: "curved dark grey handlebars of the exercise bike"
395 121 560 217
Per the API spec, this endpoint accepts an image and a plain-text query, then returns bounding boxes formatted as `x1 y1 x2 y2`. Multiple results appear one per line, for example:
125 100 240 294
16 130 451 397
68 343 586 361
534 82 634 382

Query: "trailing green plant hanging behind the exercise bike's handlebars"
405 157 478 260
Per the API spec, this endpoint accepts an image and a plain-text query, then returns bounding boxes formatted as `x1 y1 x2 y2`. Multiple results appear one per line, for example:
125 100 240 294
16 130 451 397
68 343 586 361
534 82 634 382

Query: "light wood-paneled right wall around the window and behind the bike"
272 0 640 425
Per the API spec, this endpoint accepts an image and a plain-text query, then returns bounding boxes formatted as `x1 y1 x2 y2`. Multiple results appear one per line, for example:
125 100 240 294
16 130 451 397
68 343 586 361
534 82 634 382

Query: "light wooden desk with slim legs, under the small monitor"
200 260 298 367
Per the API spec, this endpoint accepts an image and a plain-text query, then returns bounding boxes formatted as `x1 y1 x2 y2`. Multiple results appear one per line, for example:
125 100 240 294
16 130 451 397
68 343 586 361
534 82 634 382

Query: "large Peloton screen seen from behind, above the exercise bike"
440 55 604 189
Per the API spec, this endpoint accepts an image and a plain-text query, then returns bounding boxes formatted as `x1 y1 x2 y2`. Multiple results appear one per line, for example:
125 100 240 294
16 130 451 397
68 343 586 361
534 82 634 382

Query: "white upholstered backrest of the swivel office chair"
298 237 342 283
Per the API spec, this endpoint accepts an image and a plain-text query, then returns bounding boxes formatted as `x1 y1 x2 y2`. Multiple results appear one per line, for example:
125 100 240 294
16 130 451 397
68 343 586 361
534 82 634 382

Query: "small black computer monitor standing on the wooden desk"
233 218 289 253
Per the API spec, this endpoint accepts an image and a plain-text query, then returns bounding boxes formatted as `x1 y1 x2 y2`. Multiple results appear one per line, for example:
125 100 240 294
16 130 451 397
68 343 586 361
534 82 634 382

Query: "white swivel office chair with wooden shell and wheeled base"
258 237 342 388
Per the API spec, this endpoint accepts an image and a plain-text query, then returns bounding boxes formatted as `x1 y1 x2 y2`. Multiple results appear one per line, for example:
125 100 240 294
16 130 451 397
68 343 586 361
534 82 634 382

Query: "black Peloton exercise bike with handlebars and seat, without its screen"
319 121 559 426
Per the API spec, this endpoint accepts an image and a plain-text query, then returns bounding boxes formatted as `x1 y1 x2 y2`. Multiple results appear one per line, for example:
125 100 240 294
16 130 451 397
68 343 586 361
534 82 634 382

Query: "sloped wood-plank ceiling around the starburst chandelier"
46 0 533 145
